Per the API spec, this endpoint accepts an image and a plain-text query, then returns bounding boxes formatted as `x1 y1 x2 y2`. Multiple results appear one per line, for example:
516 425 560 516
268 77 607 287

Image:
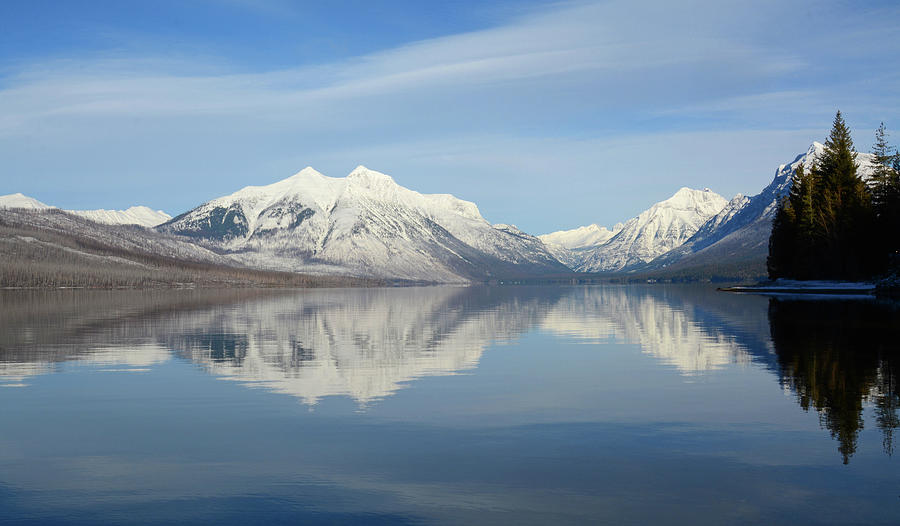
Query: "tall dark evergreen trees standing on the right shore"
767 112 900 280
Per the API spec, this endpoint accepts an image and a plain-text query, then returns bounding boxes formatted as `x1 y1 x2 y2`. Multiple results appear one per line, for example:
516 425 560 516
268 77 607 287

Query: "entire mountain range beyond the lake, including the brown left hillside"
0 143 872 287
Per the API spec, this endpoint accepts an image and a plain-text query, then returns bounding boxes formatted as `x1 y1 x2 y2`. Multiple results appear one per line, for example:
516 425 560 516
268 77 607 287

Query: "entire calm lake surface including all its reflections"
0 285 900 524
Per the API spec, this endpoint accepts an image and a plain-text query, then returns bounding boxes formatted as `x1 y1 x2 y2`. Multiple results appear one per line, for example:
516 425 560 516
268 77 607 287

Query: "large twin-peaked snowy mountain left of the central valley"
157 166 566 282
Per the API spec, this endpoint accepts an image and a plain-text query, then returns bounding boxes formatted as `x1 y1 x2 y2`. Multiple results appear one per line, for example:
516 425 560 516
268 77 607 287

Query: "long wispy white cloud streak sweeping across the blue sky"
0 3 798 122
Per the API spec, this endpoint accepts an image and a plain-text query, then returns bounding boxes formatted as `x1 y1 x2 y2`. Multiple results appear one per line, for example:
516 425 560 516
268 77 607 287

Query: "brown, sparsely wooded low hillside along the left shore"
0 209 378 288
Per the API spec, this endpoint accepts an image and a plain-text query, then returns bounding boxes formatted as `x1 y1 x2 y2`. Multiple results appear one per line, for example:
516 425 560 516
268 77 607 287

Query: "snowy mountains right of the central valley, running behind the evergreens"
539 142 874 276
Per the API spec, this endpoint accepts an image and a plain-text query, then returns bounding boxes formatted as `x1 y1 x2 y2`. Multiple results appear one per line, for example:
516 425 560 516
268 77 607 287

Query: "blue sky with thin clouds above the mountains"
0 0 900 233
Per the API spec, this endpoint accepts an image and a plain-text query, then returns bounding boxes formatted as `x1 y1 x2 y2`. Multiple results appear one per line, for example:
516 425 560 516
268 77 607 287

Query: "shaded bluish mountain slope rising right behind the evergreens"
647 142 874 276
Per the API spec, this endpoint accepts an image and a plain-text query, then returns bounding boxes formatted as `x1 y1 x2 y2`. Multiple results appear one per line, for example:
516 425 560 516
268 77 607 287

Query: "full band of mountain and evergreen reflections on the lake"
0 286 900 463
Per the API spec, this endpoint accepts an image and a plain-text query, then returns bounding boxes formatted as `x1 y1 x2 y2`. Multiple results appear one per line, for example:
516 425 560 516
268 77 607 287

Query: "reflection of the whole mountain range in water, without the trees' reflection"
0 286 771 405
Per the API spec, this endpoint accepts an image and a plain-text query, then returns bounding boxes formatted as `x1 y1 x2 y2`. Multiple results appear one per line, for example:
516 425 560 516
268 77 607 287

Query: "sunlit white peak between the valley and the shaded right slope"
575 188 727 272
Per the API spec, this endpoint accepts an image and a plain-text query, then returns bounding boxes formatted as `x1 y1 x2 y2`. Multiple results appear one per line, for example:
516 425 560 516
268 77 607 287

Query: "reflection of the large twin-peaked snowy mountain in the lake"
166 288 546 404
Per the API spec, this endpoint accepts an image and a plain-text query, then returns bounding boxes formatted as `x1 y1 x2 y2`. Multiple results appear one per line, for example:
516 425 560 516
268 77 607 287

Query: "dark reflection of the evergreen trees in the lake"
769 298 900 464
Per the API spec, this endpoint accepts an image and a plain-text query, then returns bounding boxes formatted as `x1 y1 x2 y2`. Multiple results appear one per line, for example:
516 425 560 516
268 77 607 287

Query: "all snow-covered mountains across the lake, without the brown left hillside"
0 143 873 283
